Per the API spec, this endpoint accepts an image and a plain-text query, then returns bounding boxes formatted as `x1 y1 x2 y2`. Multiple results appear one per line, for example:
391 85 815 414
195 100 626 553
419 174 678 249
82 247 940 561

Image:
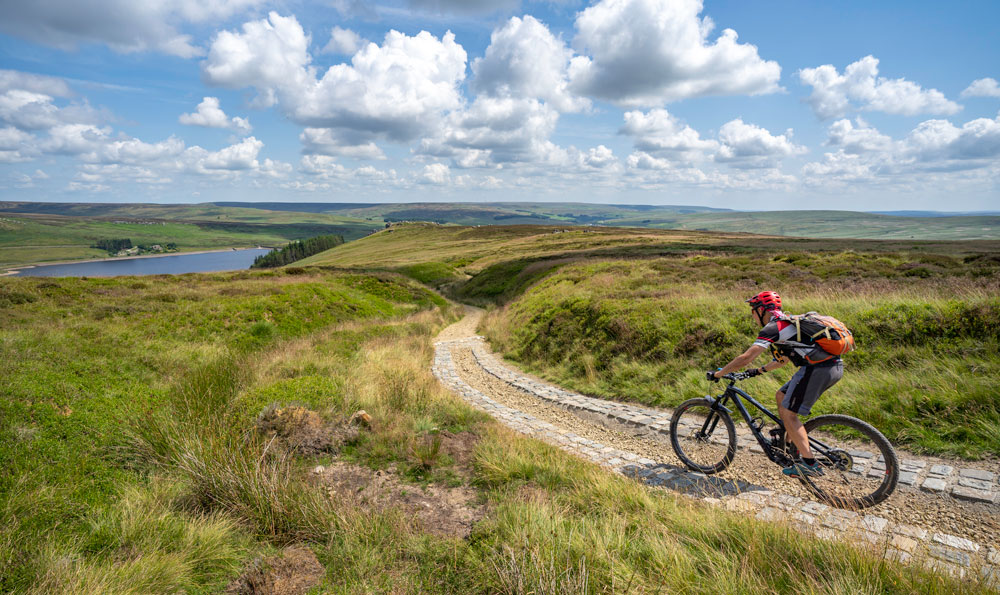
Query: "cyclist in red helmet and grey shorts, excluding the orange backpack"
707 291 844 477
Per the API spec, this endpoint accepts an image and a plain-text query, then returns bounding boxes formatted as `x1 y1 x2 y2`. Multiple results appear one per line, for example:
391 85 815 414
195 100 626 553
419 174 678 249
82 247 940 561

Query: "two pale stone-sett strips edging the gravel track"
433 309 1000 589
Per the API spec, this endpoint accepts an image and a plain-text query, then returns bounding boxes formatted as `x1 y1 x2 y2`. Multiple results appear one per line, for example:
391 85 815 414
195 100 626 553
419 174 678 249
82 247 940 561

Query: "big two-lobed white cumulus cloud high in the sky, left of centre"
203 12 466 152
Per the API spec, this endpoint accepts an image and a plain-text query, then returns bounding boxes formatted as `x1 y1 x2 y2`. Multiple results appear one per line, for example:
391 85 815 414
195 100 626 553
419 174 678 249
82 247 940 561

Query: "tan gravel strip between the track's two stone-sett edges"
438 307 1000 564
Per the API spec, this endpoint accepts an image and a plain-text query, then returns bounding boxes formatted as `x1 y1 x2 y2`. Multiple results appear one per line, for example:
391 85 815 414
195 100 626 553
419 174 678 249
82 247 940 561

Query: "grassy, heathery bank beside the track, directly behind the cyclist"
478 252 1000 458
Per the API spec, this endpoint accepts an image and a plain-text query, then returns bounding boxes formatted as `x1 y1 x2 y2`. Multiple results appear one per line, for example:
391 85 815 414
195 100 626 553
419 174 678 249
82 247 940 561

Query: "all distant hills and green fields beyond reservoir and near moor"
0 202 1000 266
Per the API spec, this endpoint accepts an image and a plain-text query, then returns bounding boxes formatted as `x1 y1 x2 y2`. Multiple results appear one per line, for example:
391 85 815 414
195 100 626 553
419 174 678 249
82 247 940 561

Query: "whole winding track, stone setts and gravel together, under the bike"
433 308 1000 588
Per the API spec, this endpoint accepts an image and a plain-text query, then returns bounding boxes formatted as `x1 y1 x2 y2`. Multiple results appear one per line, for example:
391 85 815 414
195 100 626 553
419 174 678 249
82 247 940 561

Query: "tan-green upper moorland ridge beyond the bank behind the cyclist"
302 223 1000 279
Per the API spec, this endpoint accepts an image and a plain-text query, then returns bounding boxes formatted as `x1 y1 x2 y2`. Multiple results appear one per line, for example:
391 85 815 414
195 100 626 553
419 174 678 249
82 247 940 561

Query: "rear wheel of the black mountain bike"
799 415 899 510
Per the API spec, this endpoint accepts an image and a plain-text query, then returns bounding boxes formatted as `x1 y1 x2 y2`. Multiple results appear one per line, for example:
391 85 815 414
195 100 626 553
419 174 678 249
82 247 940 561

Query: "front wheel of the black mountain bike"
670 399 736 475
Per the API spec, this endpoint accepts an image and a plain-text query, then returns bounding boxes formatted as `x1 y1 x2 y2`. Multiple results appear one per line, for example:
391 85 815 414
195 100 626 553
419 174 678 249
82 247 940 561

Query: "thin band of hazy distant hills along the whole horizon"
0 202 1000 240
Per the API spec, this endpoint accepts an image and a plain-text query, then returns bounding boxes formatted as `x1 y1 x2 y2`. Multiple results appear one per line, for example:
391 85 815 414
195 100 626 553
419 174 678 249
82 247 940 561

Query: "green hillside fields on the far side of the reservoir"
0 203 381 267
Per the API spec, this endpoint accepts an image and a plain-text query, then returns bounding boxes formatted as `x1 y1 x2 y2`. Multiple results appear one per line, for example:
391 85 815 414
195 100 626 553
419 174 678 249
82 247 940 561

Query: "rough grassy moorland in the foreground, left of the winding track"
0 267 982 593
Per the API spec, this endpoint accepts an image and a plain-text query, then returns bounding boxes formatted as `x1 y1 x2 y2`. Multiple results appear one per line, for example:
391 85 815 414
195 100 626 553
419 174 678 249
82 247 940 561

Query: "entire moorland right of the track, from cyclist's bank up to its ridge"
311 225 1000 459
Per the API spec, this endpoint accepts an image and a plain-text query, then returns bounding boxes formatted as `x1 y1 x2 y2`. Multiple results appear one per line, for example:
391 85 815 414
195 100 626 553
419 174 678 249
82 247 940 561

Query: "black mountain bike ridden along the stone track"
670 372 899 509
